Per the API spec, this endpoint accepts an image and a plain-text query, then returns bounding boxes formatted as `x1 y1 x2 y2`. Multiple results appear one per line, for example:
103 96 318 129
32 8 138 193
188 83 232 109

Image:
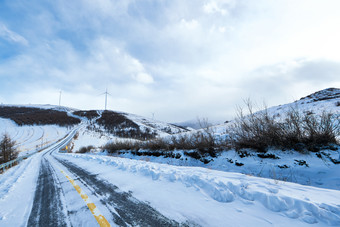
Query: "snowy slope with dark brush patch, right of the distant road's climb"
72 110 187 152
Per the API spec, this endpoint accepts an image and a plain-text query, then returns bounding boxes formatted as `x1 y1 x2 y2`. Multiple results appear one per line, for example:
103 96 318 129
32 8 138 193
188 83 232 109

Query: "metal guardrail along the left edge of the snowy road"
0 127 80 173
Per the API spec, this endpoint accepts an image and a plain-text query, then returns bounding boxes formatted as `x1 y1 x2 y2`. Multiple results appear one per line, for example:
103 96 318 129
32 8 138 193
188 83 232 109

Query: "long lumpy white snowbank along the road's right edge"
58 154 340 225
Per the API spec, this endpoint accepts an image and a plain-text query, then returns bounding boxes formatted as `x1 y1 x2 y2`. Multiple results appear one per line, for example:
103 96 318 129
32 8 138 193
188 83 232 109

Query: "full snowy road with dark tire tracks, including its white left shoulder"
0 130 186 226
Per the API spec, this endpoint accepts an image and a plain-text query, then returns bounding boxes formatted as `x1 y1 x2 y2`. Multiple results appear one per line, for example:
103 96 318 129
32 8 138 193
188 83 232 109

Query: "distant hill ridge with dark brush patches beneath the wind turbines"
0 105 187 139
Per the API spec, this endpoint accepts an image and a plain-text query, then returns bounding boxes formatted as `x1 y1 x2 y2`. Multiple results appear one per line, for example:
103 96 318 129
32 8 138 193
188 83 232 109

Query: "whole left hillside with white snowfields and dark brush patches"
0 105 187 155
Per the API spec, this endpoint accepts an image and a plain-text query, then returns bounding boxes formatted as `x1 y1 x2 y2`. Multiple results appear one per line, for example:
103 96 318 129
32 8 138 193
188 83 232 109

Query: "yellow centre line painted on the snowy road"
61 170 111 227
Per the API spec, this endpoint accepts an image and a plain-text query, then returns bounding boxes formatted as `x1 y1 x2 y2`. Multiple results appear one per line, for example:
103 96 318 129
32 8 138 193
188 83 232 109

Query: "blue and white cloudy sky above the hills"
0 0 340 122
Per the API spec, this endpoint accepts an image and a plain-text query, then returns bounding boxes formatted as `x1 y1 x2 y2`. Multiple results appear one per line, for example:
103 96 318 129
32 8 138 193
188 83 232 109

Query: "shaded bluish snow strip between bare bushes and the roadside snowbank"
107 150 340 190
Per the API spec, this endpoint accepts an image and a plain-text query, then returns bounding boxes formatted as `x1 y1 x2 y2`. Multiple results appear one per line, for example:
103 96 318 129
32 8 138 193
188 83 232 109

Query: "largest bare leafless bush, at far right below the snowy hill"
231 102 340 152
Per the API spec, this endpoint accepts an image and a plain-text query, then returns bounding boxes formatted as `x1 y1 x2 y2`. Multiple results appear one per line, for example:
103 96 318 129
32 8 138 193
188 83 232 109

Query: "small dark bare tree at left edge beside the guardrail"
0 133 18 163
